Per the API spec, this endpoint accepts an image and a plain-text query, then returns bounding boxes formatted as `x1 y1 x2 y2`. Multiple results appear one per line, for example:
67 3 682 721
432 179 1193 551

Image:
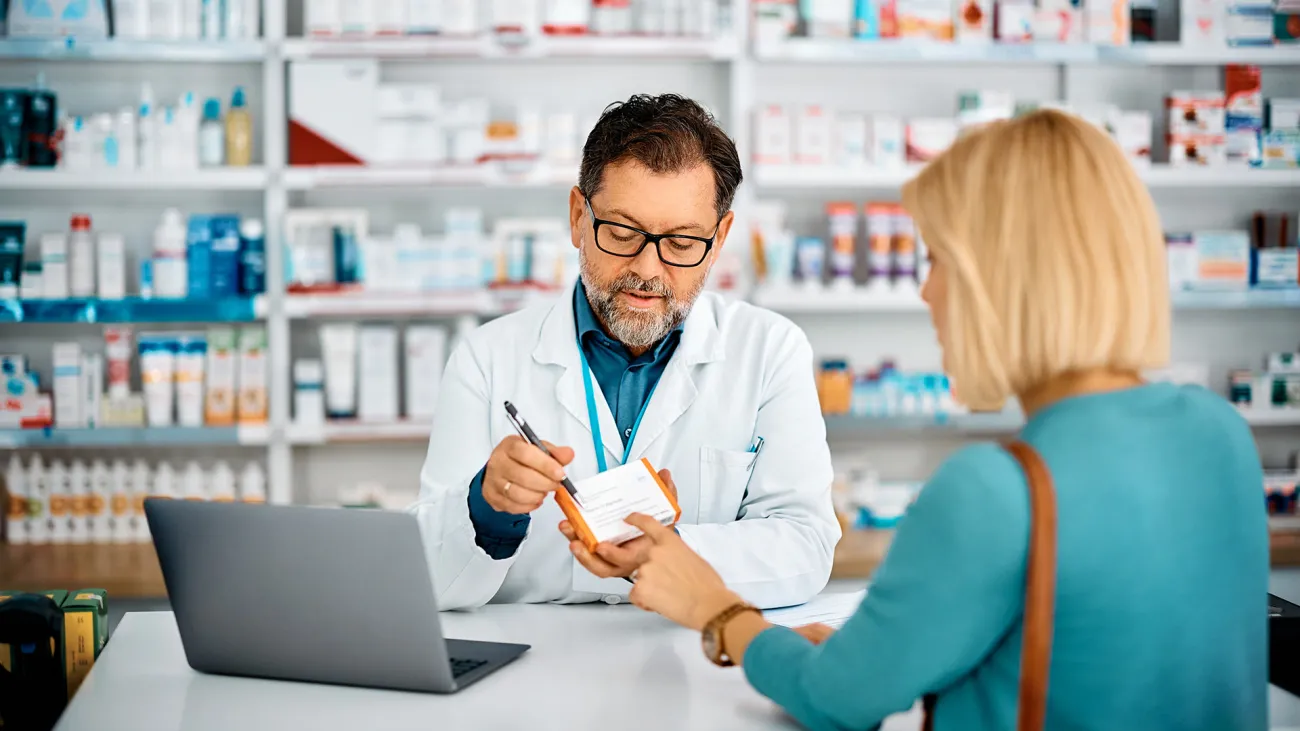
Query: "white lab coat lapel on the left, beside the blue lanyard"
533 282 623 466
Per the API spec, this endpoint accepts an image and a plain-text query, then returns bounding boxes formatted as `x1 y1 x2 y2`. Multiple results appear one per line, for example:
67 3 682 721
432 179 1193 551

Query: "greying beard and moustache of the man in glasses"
579 247 709 347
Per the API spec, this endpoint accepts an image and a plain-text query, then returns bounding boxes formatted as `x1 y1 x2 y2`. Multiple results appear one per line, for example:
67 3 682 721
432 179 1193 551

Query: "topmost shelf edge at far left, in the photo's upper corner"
0 38 267 64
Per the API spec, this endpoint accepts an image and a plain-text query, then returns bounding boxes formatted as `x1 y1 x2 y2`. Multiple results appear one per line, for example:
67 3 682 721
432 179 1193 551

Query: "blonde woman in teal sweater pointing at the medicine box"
605 112 1269 731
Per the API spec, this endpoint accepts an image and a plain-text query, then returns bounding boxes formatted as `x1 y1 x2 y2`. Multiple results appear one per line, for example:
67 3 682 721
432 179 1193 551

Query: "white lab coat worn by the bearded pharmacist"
407 284 840 609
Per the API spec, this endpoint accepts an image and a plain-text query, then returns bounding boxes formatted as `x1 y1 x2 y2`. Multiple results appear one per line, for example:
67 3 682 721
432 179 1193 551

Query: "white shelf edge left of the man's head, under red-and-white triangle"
281 165 577 190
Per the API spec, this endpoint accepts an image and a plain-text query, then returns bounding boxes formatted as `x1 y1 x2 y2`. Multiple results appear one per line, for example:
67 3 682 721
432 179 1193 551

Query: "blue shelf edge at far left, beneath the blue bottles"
0 297 267 324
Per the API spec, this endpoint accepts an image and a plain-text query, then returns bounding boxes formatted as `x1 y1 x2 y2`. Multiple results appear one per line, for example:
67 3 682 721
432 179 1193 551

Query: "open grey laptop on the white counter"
152 499 528 693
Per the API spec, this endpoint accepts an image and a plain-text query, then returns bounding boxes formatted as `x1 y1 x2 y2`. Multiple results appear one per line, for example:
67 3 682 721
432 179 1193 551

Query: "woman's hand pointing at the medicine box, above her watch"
625 512 742 630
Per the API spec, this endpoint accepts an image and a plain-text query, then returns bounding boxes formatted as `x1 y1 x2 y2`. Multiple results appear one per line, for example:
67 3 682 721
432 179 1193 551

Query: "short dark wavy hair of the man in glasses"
577 94 742 219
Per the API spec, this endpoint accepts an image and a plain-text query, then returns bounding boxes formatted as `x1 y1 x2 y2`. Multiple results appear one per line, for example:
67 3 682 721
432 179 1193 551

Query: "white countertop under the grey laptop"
56 605 1297 731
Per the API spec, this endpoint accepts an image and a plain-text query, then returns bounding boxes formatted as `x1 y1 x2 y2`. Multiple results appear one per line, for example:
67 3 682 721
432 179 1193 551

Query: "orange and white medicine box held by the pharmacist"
555 459 681 550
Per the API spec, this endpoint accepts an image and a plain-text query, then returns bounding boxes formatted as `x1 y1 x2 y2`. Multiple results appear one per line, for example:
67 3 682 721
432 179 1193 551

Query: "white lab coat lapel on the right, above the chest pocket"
621 292 725 459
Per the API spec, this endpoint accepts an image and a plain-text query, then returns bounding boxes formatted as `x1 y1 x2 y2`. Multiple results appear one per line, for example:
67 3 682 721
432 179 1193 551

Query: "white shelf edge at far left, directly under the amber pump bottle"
0 168 269 193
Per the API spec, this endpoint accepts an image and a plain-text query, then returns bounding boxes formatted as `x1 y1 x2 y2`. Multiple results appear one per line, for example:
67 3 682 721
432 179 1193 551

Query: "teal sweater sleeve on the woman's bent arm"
745 445 1030 731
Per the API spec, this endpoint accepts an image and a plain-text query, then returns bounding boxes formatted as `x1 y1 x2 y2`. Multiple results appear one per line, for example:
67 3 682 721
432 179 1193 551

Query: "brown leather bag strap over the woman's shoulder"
922 441 1057 731
